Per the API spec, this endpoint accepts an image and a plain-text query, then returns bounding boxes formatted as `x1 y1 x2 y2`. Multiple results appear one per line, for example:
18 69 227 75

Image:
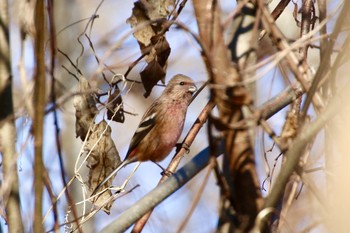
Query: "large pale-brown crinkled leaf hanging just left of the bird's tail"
84 120 121 214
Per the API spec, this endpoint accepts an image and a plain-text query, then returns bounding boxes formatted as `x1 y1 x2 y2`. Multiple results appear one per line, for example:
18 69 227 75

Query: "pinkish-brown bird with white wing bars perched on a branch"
91 74 197 196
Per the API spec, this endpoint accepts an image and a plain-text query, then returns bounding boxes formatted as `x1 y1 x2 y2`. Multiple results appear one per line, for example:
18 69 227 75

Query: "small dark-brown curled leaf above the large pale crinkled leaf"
107 86 125 123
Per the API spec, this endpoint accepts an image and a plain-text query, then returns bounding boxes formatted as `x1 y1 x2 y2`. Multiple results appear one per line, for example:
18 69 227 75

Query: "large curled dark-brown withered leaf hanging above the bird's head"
127 0 175 97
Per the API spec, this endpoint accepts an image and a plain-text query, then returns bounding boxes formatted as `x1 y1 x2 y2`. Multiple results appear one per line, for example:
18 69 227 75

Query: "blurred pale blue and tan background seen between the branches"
0 0 348 233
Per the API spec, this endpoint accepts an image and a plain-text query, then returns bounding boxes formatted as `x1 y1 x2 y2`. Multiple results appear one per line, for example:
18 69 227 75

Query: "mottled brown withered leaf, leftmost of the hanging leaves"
73 76 98 141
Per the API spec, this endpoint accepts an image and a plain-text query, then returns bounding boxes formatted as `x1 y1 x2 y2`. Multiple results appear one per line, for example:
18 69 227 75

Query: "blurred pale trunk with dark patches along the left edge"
0 0 24 233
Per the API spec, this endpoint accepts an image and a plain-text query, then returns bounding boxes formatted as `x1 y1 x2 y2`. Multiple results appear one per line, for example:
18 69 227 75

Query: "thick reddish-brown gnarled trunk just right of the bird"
193 0 263 232
